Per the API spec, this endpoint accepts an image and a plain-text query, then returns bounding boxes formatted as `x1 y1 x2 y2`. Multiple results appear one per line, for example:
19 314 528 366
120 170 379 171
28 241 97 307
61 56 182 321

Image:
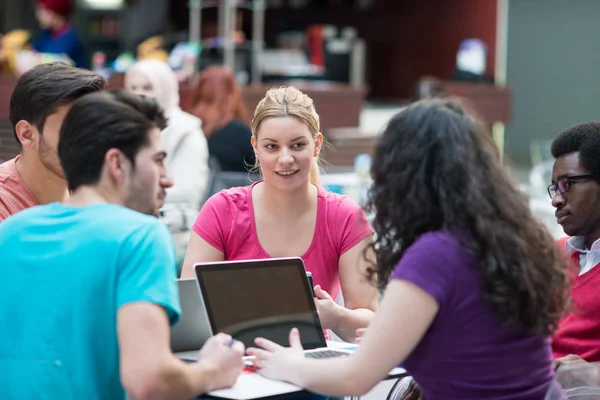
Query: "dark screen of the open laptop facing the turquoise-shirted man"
195 258 326 349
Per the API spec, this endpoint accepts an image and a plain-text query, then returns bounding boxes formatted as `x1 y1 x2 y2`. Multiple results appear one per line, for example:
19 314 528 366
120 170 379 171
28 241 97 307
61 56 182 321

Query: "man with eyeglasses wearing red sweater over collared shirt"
548 122 600 367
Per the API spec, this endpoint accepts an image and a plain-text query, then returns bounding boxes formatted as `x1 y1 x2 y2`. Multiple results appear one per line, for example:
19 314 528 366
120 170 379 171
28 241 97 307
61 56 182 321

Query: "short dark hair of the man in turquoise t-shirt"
58 90 166 190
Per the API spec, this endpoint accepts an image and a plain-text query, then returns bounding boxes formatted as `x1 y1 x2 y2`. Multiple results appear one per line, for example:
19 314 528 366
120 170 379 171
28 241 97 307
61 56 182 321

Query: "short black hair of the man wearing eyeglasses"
550 121 600 180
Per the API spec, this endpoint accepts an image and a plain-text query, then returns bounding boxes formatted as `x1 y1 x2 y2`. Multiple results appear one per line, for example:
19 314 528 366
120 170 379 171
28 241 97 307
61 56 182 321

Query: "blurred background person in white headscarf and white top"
125 60 209 213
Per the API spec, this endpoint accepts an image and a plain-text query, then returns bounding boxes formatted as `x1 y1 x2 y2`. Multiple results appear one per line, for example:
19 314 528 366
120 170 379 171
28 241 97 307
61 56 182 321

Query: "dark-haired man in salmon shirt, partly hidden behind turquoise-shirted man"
0 63 106 222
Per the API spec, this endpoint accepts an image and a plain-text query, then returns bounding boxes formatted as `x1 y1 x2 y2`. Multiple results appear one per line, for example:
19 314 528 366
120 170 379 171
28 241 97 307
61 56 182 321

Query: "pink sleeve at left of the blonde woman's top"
192 192 232 252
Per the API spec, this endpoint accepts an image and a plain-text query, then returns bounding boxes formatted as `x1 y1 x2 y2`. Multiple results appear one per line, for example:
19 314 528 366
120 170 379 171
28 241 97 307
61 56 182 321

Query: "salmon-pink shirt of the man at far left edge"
0 156 38 222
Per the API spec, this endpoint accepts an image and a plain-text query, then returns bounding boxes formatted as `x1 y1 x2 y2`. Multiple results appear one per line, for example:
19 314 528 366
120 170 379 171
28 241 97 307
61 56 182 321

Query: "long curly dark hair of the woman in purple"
365 99 569 334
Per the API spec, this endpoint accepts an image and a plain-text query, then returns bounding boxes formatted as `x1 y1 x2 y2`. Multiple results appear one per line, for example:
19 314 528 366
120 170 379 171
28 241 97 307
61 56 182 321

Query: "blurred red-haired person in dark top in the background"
191 66 254 172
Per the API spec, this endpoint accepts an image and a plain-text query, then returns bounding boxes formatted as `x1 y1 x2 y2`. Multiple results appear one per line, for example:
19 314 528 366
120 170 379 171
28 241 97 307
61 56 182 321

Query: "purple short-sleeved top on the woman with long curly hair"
392 231 552 400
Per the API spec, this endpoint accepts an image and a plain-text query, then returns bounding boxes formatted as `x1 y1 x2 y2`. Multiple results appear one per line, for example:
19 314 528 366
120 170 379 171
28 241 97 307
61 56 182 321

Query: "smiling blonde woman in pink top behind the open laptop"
182 87 378 341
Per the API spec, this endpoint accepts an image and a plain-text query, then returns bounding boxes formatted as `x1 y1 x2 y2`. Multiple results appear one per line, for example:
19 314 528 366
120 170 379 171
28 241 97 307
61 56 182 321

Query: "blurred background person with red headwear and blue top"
32 0 89 68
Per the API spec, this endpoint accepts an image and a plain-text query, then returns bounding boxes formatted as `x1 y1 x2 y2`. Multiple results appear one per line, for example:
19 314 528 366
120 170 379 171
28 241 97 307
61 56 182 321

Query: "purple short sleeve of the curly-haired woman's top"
391 232 466 309
